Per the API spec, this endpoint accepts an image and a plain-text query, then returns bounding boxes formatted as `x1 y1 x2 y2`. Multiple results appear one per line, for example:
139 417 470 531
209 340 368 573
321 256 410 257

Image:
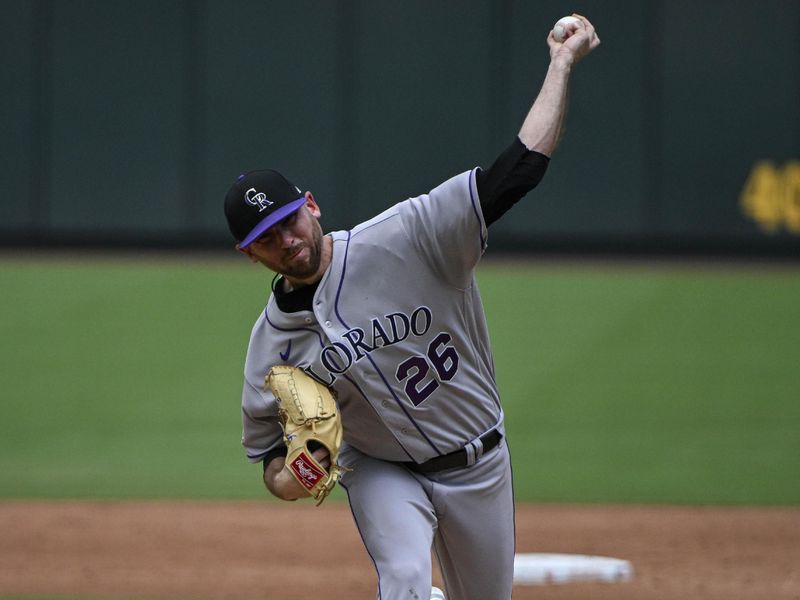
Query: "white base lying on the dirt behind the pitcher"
514 553 633 585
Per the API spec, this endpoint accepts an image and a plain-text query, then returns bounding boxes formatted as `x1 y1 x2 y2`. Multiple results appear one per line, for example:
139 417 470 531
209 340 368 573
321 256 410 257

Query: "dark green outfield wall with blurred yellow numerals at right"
0 0 800 256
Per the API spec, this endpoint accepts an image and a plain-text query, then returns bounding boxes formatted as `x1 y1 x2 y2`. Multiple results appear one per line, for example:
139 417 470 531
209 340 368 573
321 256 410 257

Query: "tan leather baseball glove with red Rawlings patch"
265 365 343 506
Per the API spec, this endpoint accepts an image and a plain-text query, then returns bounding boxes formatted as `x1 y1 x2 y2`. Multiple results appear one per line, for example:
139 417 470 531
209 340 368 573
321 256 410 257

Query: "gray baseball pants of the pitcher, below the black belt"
340 440 515 600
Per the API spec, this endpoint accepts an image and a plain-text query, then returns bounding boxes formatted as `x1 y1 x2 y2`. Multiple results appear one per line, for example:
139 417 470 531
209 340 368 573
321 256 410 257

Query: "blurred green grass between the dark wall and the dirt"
0 256 800 505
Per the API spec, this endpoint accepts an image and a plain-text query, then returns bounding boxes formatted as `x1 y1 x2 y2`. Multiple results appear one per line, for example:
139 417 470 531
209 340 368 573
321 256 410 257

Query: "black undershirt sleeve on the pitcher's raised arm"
475 137 550 227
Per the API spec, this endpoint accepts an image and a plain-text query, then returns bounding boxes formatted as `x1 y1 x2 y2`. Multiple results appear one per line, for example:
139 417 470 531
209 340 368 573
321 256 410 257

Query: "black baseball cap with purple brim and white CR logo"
225 169 306 248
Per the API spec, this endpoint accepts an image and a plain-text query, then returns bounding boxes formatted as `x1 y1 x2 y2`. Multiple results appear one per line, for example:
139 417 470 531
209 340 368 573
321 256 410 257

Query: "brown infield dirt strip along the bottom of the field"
0 501 800 600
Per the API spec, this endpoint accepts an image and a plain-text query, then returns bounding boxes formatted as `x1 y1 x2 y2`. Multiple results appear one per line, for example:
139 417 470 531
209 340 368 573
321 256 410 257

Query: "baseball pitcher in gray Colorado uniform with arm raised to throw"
225 17 600 600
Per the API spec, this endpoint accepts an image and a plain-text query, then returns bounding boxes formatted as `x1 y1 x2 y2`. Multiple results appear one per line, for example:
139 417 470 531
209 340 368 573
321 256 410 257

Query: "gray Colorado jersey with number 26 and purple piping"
242 170 503 462
